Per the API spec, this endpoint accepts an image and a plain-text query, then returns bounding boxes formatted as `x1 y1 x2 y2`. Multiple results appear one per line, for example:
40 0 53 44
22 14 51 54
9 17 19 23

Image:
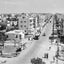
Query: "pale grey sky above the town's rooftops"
0 0 64 13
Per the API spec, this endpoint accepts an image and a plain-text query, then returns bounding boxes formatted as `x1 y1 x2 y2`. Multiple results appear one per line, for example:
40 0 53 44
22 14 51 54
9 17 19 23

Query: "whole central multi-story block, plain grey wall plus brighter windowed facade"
18 13 38 33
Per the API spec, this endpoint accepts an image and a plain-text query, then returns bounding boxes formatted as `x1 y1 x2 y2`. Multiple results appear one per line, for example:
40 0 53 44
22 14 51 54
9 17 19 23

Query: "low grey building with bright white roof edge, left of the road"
5 30 24 42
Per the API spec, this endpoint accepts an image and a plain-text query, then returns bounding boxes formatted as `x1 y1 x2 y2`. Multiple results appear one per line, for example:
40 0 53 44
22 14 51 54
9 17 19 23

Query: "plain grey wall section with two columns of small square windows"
18 13 29 33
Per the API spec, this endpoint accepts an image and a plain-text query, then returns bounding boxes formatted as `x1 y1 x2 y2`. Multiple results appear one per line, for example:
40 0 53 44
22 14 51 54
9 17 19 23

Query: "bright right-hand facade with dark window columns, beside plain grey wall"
29 14 40 34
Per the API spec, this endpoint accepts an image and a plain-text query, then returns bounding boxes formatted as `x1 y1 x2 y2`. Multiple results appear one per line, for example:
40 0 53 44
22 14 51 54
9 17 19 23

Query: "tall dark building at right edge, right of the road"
54 14 64 43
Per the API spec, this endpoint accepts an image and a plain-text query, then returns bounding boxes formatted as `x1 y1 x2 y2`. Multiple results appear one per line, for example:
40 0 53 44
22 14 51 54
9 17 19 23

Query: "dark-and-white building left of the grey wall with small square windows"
6 14 18 30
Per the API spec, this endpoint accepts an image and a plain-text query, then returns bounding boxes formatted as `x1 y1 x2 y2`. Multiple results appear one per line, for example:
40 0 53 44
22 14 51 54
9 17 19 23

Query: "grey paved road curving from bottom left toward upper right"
1 20 52 64
